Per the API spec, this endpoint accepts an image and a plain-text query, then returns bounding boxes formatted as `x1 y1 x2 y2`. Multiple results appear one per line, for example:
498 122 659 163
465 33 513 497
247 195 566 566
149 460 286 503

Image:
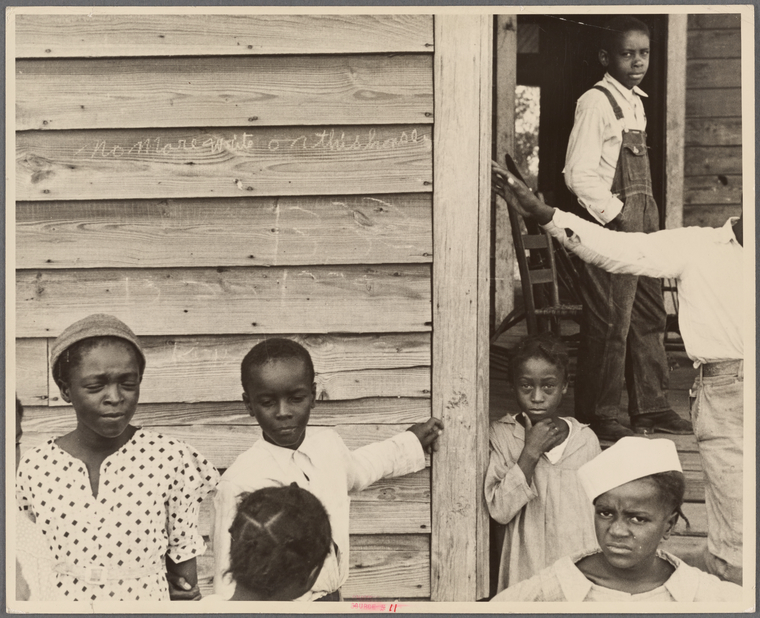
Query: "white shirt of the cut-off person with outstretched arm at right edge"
545 210 744 366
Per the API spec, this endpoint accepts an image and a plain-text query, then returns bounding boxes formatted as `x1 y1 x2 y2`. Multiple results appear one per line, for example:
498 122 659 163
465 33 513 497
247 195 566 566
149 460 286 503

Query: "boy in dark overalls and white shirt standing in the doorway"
564 16 692 441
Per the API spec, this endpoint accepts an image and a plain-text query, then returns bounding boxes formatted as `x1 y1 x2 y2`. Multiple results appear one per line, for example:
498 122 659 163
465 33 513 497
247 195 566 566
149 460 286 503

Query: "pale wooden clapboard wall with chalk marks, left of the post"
15 13 434 599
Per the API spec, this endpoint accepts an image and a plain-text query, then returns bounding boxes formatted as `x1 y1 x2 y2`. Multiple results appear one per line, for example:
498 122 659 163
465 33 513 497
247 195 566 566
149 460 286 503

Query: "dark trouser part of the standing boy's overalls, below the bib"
575 195 670 422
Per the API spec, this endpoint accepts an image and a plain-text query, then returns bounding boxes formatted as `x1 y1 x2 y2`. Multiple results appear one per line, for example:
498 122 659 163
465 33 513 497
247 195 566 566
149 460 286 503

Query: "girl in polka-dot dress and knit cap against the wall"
16 314 219 602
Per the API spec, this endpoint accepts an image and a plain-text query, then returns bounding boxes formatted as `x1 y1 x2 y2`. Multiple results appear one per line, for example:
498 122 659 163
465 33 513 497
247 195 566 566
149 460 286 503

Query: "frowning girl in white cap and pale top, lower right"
492 437 741 602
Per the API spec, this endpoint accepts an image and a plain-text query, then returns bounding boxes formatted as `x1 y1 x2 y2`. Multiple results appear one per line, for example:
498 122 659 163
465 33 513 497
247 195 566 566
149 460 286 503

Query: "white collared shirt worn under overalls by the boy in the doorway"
563 73 647 225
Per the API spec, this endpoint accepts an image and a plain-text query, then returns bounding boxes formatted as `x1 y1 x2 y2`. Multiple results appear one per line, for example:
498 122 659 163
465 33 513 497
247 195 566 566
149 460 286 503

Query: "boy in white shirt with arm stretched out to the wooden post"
214 338 443 601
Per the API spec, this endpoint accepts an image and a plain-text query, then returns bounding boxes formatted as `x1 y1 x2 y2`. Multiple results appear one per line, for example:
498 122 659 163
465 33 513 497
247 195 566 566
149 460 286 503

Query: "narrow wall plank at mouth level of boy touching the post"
24 398 430 426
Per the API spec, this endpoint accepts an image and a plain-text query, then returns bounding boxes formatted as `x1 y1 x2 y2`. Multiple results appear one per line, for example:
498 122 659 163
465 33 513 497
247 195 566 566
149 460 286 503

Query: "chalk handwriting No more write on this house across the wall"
74 128 431 159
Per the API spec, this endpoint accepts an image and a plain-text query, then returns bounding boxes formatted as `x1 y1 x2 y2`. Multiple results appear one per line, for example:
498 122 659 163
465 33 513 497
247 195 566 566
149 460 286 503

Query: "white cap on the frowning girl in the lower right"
578 436 682 502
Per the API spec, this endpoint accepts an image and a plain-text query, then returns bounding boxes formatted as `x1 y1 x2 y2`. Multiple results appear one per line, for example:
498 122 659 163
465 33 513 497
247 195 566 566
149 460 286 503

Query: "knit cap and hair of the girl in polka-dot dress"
50 313 145 386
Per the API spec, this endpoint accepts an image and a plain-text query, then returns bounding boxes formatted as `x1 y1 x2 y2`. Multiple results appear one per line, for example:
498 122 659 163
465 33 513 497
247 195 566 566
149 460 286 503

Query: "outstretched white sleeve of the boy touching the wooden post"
341 431 425 491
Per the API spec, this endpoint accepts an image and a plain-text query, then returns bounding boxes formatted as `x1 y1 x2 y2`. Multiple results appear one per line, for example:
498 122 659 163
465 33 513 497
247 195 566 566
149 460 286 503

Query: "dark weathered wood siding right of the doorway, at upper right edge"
683 14 742 227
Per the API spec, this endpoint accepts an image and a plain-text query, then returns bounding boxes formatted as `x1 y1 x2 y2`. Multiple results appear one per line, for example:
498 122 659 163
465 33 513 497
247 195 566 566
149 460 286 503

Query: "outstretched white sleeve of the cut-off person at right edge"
544 210 690 278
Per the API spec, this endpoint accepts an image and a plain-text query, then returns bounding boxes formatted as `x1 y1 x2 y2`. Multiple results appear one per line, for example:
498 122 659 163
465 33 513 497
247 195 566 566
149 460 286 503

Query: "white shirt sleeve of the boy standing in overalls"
564 93 623 225
